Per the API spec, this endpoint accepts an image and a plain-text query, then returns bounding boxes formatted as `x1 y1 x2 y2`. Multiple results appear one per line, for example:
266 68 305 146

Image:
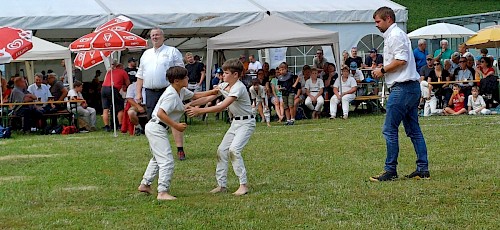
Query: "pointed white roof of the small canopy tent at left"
16 36 71 61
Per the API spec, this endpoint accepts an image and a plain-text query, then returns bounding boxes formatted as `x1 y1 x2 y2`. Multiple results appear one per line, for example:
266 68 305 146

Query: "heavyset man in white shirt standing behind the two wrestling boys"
135 28 185 160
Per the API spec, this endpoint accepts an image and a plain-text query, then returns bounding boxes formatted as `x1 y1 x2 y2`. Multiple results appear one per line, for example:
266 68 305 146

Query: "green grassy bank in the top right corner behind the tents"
392 0 500 32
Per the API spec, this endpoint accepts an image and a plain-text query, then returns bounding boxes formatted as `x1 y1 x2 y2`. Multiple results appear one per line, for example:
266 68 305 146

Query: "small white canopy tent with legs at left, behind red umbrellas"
14 36 73 88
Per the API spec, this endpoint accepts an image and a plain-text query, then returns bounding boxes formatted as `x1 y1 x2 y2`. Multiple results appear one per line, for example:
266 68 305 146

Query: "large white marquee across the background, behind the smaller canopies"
0 0 408 50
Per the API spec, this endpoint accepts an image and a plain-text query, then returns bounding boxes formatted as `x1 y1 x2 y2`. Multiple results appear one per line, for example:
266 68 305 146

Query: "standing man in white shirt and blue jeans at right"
370 7 430 181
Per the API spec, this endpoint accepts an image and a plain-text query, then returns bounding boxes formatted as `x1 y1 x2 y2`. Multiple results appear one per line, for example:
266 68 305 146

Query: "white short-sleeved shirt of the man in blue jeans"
383 23 420 87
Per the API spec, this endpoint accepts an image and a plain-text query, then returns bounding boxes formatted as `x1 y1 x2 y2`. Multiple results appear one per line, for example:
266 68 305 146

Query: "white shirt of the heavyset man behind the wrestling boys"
136 45 184 89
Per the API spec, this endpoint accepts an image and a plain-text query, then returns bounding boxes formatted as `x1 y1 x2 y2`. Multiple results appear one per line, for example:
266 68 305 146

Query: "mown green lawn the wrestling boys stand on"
0 115 500 229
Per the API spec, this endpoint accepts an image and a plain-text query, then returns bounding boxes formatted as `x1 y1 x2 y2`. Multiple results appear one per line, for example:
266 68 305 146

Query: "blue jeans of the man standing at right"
382 81 429 172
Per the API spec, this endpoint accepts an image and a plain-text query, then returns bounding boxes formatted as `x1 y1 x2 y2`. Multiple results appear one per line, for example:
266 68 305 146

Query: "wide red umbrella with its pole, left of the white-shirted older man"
69 26 147 137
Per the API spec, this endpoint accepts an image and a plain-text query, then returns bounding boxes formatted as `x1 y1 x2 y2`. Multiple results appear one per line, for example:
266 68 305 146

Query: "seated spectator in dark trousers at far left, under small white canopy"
9 77 42 132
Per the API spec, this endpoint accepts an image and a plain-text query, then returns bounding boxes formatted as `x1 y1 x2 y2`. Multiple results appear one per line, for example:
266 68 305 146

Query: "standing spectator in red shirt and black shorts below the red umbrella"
101 63 130 132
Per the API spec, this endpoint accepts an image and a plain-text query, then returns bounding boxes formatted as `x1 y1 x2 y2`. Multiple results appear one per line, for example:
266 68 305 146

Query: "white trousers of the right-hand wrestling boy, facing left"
215 119 255 187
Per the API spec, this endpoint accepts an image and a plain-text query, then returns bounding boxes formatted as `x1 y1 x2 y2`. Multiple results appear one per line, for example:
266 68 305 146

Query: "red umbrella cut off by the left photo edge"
0 27 33 64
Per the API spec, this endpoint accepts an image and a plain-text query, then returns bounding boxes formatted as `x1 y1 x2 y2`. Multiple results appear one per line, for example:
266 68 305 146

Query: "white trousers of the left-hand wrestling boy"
141 122 174 192
